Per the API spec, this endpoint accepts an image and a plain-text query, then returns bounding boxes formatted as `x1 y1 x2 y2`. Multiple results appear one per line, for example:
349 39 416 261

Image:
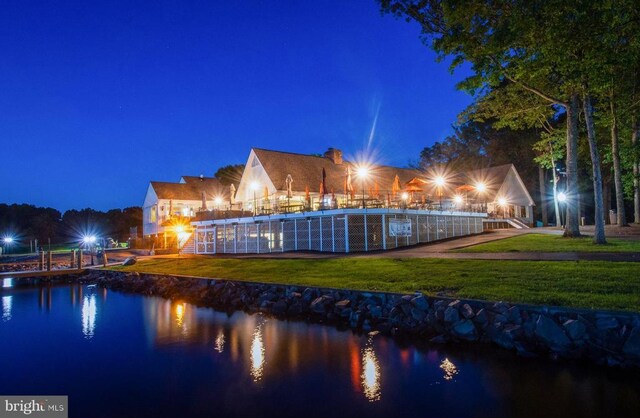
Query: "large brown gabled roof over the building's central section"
253 148 420 193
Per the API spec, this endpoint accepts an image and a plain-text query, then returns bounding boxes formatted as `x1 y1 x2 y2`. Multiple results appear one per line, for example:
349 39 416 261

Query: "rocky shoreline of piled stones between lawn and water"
40 270 640 368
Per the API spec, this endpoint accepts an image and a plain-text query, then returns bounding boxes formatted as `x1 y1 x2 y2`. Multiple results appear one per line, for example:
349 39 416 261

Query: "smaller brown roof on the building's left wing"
151 176 228 201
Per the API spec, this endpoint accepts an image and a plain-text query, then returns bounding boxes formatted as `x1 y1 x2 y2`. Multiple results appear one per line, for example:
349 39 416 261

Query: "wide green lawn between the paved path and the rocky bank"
114 257 640 311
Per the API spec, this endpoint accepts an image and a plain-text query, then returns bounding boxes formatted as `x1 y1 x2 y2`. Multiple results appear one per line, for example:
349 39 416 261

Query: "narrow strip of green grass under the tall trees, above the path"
454 234 640 253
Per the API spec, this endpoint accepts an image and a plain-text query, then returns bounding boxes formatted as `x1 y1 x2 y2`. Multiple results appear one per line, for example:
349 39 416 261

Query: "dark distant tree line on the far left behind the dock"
0 204 142 247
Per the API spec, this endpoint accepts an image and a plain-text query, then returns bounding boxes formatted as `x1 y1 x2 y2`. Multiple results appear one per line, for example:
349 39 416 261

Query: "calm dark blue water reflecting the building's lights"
0 279 640 418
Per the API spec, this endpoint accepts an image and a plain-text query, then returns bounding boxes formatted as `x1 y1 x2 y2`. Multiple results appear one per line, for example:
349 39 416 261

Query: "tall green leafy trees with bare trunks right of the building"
379 0 640 244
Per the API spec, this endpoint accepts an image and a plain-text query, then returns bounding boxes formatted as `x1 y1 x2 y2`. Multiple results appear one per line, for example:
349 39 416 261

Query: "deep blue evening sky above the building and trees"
0 0 470 210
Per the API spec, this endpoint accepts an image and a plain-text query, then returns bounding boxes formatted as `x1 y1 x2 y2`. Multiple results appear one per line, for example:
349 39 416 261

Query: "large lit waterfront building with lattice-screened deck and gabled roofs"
143 148 534 254
